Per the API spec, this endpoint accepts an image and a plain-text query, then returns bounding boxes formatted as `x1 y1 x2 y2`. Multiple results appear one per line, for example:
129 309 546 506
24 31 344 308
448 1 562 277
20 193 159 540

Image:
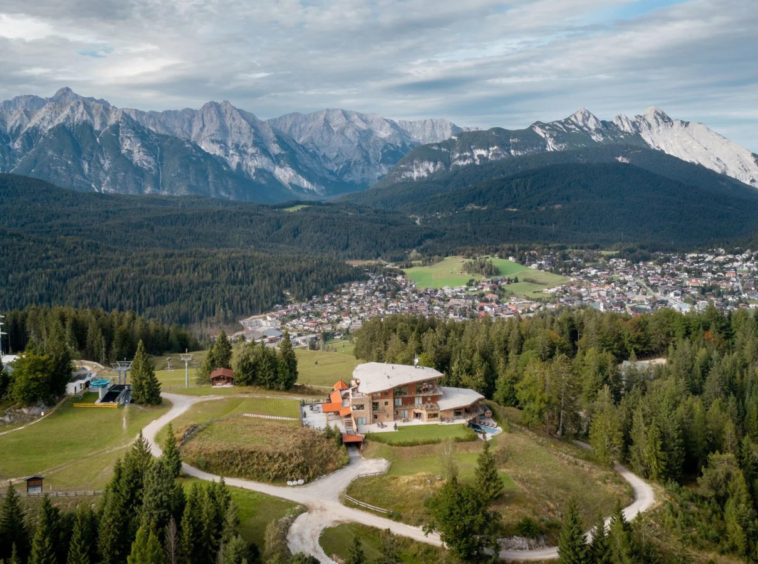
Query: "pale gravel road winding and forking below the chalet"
142 393 654 564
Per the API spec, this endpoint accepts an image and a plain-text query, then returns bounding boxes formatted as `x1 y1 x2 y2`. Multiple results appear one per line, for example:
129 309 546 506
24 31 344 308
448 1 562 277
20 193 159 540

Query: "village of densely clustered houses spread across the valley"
234 249 758 346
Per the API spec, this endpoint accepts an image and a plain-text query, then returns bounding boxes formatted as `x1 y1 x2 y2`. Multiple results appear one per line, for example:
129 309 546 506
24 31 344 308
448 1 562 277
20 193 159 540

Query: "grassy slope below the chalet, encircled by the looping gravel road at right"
348 429 632 541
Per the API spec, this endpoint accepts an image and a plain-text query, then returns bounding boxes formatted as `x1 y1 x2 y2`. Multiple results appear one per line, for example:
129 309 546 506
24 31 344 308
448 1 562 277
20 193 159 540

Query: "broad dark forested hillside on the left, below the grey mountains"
0 175 424 323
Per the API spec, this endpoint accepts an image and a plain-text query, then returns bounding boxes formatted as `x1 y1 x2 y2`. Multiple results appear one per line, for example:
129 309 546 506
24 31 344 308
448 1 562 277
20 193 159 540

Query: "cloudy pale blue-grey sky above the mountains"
0 0 758 153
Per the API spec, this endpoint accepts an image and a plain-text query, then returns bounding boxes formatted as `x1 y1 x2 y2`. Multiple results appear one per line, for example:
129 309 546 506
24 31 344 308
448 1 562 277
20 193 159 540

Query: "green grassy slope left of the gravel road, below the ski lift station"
0 398 170 490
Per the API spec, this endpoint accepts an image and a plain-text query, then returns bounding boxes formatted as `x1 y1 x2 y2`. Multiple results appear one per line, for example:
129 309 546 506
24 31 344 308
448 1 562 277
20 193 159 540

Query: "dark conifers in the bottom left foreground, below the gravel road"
0 426 318 564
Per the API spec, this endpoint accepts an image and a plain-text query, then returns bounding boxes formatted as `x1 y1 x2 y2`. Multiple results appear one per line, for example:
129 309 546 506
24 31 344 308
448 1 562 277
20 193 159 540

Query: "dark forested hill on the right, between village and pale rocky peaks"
418 163 758 245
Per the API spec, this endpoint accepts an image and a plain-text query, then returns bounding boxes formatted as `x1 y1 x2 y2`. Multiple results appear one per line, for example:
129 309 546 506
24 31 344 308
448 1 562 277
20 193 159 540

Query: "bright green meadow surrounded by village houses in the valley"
404 256 567 298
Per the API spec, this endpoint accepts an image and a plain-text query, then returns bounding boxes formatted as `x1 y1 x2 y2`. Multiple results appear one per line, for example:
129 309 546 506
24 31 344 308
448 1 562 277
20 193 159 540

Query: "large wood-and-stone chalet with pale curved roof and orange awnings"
322 362 484 433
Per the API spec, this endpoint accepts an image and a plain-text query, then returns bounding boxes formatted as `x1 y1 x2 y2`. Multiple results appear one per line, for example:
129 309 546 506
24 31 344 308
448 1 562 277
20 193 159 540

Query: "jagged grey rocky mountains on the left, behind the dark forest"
0 88 464 202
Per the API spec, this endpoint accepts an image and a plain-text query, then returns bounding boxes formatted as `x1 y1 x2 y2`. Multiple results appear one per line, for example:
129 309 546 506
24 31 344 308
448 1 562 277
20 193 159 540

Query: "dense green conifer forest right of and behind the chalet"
355 306 758 561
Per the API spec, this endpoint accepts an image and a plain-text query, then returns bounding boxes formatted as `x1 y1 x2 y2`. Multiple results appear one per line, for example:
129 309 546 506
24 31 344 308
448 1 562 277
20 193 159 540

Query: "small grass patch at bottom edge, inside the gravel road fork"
319 523 443 564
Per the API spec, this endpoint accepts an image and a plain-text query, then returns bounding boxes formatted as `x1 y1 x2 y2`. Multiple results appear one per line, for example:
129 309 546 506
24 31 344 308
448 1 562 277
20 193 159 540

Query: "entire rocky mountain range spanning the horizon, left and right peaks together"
0 88 758 202
